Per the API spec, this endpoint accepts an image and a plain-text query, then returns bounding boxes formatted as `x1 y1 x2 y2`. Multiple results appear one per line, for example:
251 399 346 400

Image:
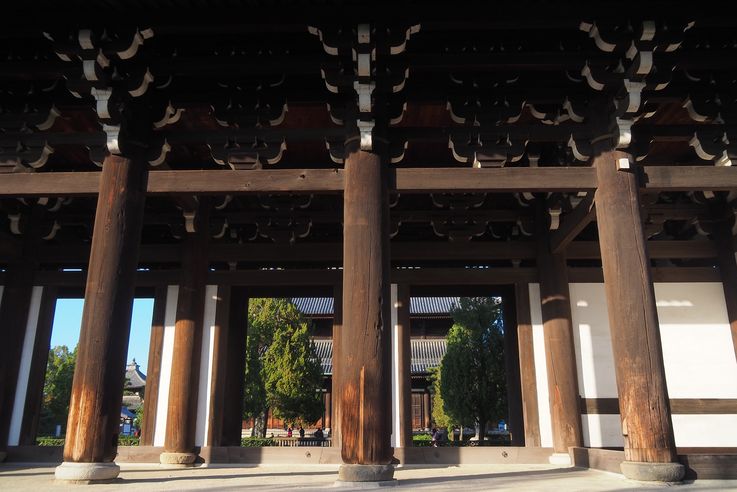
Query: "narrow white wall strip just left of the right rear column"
529 284 553 448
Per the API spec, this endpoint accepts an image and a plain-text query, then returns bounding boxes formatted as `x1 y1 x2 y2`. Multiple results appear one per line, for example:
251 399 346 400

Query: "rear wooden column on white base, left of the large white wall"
536 204 583 464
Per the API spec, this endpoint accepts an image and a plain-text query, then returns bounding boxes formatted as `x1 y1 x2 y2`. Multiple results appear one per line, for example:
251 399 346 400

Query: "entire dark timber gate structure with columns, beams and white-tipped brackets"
0 0 737 481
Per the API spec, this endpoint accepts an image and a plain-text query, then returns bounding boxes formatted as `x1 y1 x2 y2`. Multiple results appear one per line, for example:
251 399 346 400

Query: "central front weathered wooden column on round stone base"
338 147 393 481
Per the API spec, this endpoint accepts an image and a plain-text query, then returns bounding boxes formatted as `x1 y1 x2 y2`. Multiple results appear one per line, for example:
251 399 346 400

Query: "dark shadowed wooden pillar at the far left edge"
0 207 42 461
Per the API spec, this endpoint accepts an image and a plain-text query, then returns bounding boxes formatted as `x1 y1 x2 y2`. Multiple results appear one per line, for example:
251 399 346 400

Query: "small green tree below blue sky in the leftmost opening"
39 345 77 435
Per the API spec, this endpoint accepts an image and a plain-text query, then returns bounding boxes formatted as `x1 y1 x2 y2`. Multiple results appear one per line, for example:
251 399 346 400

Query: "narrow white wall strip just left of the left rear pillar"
154 285 179 446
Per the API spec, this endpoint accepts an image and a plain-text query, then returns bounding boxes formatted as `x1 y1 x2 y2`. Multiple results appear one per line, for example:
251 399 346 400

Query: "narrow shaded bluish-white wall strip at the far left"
8 286 43 446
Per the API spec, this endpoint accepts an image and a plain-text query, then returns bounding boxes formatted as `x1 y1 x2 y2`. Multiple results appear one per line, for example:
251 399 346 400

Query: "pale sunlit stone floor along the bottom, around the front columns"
0 464 737 492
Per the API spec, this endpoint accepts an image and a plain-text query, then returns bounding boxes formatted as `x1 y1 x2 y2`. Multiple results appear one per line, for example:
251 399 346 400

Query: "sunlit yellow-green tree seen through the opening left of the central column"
243 298 322 437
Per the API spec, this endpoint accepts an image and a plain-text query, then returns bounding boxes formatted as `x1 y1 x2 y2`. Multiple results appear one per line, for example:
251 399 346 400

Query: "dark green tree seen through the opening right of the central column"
440 297 507 445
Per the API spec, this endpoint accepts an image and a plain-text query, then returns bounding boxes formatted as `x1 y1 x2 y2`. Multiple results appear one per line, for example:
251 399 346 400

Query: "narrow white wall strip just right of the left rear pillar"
194 285 218 446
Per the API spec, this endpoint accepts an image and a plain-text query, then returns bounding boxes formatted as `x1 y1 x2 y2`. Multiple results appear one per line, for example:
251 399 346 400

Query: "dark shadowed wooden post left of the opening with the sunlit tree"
220 287 248 446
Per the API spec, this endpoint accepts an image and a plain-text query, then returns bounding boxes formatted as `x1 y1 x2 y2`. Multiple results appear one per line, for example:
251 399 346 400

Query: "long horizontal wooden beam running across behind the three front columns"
0 166 737 197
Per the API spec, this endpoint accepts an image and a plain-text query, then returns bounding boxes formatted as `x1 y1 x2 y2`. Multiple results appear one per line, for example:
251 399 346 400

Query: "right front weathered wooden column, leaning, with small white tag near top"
594 152 684 481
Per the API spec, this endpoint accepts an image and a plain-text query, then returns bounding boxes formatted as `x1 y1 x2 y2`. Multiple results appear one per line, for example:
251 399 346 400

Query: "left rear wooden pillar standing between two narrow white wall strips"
160 203 209 465
